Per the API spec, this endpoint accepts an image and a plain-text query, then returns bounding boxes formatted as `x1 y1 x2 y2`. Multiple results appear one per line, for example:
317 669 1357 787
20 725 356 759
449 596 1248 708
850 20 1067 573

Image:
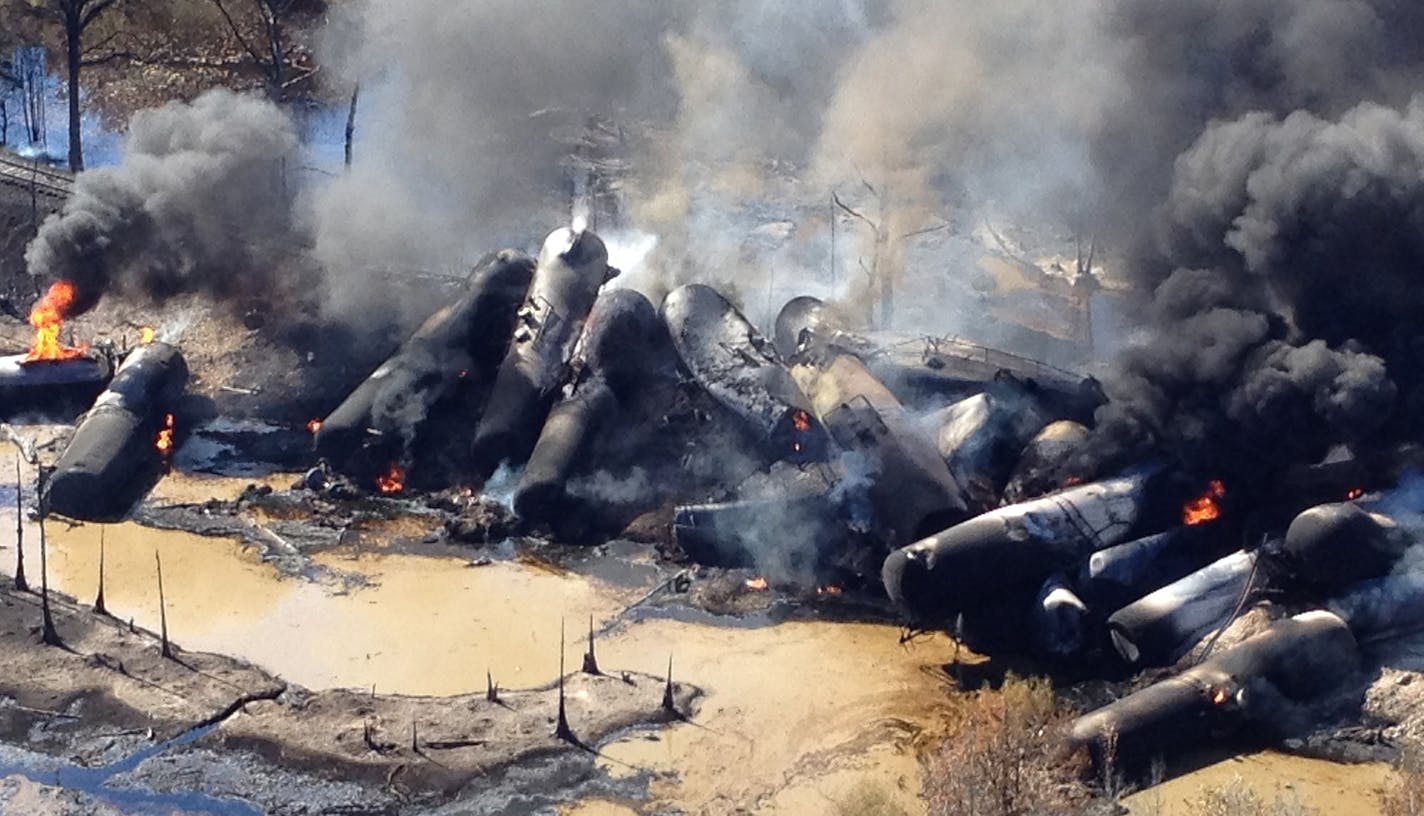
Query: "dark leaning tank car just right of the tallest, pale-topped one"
514 289 676 527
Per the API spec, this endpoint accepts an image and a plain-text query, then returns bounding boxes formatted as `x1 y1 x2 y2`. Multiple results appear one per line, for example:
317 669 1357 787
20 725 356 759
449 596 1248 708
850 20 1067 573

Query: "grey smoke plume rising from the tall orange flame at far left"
26 90 300 312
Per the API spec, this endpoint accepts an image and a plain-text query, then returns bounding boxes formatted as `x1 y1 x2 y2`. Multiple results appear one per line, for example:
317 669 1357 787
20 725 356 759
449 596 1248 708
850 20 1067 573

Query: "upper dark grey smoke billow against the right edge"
1162 98 1424 353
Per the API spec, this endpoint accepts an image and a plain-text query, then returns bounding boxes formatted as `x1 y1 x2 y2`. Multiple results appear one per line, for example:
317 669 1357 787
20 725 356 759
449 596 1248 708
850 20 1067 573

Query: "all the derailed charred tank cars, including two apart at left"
11 228 1424 762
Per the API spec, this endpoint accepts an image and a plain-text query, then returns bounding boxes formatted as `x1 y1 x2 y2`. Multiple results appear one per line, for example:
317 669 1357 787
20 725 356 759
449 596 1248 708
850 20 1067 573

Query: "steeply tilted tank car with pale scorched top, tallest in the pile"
471 228 618 478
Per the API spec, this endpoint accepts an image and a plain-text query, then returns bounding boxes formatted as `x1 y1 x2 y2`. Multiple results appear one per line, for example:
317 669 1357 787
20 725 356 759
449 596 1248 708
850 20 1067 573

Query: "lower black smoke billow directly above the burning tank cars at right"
1064 269 1396 484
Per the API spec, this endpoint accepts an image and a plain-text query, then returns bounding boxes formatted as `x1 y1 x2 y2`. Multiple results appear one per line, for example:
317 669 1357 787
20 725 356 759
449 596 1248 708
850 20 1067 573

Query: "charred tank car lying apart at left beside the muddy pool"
41 343 188 521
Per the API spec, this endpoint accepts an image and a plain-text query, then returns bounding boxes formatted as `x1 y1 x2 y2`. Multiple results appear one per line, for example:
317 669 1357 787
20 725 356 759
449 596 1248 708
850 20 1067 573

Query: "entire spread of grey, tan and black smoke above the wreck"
22 0 1424 489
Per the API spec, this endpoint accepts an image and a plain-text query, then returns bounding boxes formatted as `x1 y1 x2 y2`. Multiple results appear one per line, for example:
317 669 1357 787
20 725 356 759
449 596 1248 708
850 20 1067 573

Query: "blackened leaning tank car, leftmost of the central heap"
316 249 534 481
